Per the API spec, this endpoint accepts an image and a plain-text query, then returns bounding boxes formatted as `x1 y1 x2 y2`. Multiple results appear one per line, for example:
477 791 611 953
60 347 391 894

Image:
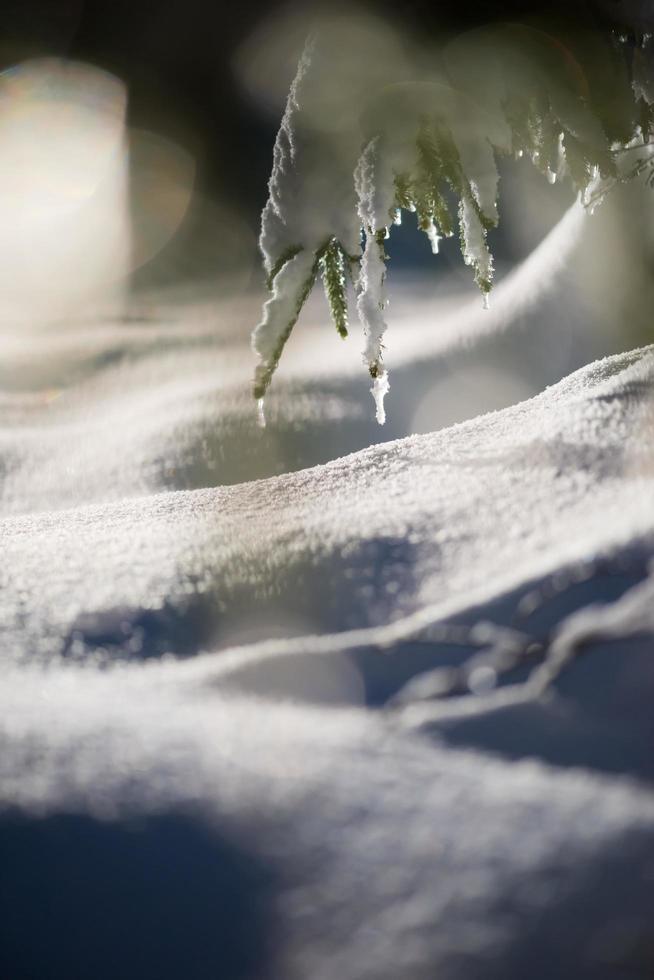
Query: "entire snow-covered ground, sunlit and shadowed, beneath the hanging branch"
0 211 654 980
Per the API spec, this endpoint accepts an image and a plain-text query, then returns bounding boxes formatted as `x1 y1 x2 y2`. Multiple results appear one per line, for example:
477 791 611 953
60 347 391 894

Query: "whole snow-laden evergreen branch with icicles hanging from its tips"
252 25 654 423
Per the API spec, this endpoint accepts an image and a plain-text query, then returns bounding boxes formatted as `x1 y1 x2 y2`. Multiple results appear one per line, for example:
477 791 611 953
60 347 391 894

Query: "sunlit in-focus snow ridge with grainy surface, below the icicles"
9 334 652 658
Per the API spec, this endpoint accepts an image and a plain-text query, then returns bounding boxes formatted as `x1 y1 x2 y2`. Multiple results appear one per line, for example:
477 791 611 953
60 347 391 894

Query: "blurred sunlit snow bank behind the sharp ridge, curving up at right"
0 198 593 514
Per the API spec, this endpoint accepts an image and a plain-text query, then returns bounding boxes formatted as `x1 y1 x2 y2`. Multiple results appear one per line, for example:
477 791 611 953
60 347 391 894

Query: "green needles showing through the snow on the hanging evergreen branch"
254 30 654 398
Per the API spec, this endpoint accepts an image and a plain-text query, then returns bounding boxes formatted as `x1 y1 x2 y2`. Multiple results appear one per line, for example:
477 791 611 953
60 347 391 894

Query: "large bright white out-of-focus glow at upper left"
0 58 130 324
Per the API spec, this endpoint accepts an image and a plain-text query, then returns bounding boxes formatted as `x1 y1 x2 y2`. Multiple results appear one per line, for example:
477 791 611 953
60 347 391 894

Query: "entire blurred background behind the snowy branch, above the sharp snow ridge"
0 0 654 509
